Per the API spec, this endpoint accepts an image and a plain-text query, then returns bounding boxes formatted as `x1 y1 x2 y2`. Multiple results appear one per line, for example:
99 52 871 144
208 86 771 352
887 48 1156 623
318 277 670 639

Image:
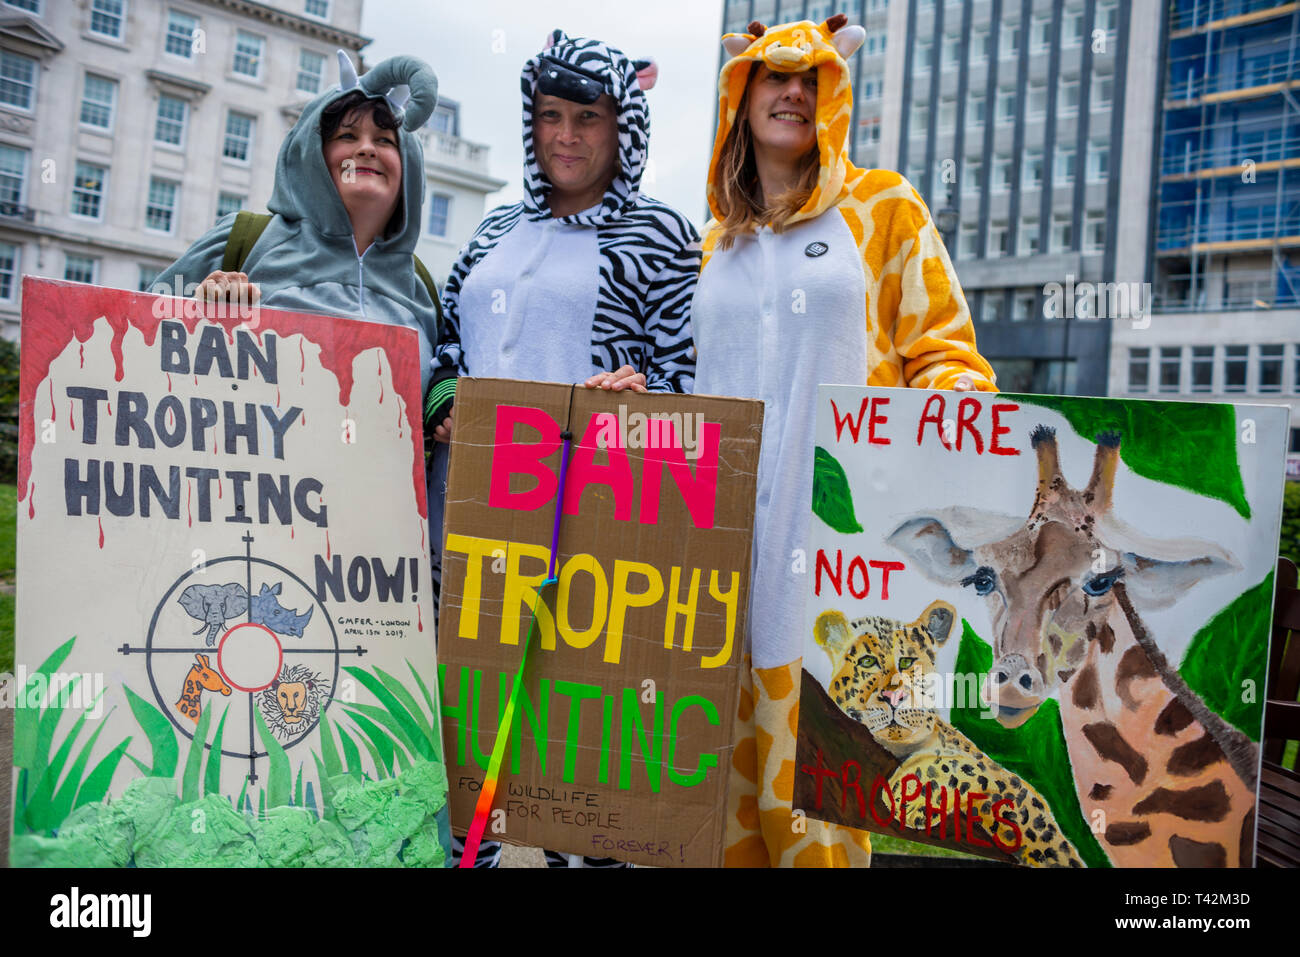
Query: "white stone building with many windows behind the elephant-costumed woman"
0 0 501 338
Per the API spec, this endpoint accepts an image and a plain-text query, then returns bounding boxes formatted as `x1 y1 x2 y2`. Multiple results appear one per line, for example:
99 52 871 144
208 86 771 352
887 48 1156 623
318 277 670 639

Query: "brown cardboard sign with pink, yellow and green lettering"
439 378 762 866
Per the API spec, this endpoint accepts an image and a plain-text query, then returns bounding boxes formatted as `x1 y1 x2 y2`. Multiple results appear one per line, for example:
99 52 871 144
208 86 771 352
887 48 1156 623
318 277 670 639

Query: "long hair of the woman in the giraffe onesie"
714 72 822 250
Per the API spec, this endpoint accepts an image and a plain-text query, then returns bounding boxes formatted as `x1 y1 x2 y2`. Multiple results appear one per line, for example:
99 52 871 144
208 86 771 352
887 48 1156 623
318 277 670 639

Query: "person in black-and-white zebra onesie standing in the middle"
426 30 699 867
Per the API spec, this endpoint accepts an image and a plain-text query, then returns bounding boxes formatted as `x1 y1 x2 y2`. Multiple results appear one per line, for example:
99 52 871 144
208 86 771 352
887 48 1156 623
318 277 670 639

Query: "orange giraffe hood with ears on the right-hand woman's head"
707 13 866 224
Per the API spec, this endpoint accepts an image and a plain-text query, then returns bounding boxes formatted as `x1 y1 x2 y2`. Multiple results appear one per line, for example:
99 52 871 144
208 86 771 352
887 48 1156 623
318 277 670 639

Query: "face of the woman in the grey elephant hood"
321 108 402 221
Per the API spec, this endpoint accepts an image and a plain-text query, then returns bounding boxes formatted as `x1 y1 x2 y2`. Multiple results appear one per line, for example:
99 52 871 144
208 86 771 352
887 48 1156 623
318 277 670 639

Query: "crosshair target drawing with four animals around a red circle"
117 534 365 781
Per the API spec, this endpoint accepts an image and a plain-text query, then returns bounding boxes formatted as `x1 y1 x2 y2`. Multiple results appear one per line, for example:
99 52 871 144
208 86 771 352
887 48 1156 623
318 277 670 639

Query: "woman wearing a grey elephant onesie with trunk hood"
155 51 438 398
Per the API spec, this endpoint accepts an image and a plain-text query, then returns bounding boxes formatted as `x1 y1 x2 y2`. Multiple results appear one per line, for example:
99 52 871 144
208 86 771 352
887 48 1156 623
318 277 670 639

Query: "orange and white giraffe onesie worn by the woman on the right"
692 16 995 867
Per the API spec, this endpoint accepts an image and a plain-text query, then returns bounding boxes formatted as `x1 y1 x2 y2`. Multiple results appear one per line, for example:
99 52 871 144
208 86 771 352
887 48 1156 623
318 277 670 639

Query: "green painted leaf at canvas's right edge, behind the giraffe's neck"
1178 572 1273 741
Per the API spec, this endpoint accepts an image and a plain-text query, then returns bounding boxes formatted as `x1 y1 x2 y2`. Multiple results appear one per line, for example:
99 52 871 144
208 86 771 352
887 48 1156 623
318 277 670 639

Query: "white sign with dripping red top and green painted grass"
12 278 450 867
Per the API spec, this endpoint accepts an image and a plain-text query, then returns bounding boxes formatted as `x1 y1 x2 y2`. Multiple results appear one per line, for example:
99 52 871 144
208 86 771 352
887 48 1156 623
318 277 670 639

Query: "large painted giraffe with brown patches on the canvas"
888 425 1258 867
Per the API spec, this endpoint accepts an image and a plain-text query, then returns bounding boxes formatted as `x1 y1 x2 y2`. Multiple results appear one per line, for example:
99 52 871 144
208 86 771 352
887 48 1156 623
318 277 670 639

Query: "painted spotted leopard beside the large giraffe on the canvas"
814 601 1083 867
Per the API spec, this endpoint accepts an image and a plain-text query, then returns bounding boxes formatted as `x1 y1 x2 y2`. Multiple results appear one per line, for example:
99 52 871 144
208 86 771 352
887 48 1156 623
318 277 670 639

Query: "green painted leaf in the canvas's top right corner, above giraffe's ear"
1000 393 1251 519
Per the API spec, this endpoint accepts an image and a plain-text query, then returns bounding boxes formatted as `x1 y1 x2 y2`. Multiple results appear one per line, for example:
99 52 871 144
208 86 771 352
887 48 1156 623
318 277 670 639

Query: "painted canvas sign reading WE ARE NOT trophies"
796 386 1288 867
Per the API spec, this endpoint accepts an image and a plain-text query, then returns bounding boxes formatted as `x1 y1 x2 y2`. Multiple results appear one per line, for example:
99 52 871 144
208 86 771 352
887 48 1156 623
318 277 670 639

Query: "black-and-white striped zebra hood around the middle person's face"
520 30 650 226
